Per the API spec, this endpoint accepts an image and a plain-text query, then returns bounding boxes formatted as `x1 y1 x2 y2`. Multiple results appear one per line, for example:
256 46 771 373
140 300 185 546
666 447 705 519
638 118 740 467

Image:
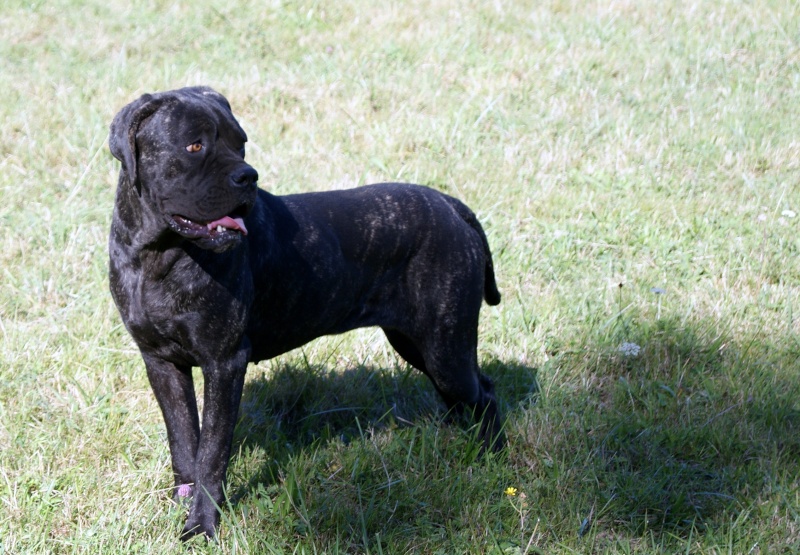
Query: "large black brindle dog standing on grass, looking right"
109 87 503 539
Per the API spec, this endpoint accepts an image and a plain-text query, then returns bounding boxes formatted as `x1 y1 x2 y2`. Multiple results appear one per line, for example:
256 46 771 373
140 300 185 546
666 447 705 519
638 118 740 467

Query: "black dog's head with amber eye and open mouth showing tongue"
108 87 258 252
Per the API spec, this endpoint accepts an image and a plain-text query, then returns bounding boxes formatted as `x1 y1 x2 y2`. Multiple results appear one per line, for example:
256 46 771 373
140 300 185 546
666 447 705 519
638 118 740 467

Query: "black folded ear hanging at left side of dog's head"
108 94 165 195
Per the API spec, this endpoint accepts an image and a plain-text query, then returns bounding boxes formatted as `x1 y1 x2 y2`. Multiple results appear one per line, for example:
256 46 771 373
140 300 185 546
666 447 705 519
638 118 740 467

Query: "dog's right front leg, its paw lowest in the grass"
181 349 249 540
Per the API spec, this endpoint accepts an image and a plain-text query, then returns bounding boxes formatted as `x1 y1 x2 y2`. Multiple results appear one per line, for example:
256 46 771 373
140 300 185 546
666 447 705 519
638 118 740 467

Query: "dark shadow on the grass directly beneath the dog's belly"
232 360 539 502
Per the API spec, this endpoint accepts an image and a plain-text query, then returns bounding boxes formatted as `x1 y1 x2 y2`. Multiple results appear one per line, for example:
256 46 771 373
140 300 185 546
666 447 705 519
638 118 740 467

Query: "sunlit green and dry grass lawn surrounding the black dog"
0 0 800 554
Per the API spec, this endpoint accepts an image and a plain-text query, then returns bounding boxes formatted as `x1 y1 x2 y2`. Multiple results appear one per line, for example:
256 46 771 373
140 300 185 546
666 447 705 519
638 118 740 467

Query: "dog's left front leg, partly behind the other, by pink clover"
143 354 200 501
